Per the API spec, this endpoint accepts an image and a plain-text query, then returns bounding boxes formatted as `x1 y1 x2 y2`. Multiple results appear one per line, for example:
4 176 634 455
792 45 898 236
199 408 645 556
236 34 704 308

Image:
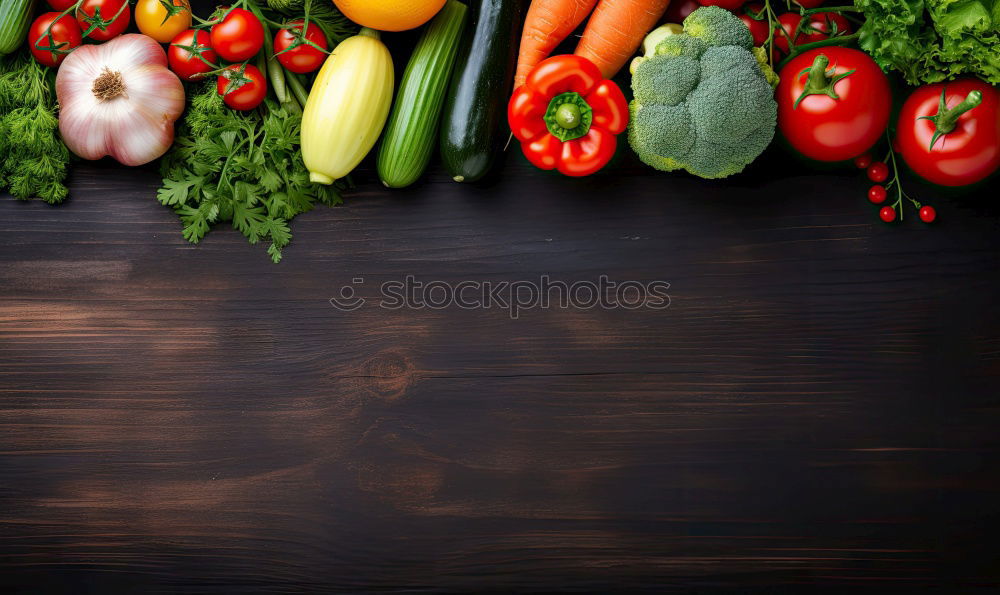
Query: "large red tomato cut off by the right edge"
896 79 1000 186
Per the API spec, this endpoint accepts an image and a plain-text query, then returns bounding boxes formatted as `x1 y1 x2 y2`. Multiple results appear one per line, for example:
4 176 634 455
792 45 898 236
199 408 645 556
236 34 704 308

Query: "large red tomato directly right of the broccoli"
775 47 892 161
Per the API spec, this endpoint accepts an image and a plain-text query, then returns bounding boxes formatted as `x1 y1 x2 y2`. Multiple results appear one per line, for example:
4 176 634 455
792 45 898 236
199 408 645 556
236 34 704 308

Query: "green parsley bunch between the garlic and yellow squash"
157 83 341 262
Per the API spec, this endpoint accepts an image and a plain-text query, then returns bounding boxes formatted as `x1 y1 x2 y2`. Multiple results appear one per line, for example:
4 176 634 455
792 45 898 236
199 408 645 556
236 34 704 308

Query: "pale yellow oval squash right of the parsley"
302 28 393 184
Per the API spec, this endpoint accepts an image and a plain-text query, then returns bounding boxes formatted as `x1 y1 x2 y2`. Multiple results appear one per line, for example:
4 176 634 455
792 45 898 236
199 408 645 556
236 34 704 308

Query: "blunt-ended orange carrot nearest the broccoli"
574 0 670 78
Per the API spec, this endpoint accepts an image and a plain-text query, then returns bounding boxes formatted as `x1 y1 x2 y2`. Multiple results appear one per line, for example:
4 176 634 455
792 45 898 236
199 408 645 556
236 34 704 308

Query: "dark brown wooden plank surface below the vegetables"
0 152 1000 593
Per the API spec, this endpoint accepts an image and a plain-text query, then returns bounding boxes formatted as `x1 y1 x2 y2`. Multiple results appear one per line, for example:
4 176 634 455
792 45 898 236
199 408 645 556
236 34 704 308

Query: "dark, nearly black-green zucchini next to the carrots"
441 0 526 182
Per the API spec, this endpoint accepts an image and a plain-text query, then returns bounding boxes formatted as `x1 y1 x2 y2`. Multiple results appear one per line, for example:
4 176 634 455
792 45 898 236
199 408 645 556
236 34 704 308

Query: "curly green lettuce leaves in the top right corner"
855 0 1000 85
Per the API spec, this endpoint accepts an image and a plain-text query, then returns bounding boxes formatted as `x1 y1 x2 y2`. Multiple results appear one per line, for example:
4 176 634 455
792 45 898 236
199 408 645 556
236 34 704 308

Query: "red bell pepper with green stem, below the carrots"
507 55 628 176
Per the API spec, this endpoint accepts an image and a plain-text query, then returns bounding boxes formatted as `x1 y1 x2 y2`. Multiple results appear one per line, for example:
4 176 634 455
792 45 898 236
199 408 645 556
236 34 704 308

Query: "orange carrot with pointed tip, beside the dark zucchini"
514 0 597 89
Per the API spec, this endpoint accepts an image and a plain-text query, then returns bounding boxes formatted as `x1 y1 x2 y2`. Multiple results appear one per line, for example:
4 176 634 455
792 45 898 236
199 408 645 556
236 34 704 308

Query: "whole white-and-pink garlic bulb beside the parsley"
56 33 184 165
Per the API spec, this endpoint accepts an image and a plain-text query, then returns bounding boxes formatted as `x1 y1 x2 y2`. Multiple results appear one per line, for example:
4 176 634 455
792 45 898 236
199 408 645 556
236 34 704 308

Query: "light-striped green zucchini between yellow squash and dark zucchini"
376 0 467 188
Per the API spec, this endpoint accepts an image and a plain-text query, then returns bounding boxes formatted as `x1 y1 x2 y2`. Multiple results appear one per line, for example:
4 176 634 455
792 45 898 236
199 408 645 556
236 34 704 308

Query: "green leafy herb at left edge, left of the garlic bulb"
0 49 70 204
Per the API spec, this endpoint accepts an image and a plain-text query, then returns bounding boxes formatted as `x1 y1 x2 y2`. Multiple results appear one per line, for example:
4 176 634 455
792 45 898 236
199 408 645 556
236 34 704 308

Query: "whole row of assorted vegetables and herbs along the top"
0 0 1000 262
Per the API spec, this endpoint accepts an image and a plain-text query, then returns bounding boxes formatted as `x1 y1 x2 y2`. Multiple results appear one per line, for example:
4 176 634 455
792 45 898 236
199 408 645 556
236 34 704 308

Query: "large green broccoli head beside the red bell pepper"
629 6 778 178
